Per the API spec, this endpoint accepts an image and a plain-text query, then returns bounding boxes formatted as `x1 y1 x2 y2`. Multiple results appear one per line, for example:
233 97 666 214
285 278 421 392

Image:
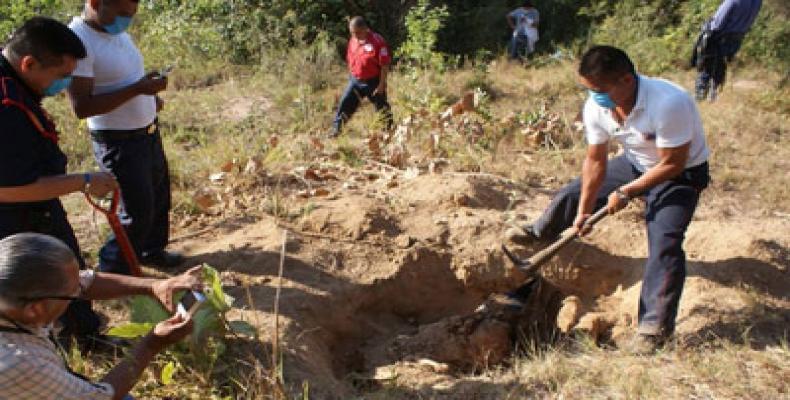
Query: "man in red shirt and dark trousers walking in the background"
329 17 393 137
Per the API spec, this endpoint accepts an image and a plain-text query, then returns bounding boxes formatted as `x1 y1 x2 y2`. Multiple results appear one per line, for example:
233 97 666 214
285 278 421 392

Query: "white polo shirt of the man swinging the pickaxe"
584 75 710 172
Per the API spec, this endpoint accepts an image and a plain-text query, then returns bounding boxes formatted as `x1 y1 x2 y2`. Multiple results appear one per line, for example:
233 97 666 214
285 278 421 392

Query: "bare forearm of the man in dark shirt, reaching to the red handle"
0 174 85 203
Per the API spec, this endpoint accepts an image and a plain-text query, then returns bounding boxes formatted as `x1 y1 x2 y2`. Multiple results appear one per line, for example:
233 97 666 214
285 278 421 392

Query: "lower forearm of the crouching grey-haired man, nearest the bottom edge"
101 334 163 400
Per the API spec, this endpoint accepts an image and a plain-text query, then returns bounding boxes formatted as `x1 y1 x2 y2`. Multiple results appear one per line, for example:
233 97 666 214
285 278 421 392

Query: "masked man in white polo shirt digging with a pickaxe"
507 46 710 353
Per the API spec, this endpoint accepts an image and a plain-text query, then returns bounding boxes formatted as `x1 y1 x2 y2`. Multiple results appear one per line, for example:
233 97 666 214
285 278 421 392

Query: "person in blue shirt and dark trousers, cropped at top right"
692 0 763 101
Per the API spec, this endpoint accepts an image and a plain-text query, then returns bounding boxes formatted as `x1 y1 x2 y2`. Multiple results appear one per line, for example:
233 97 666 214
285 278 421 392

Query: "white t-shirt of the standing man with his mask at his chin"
69 17 156 130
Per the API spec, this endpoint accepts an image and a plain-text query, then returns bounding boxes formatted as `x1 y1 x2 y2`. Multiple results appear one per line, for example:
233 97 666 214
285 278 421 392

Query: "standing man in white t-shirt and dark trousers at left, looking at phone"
69 0 182 274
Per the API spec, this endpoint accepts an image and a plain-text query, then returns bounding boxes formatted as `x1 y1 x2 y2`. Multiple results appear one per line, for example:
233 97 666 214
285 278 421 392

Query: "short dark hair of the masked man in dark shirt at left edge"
6 17 87 67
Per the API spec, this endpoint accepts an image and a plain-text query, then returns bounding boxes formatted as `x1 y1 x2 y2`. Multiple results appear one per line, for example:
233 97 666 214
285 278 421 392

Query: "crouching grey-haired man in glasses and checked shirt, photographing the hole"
0 233 201 400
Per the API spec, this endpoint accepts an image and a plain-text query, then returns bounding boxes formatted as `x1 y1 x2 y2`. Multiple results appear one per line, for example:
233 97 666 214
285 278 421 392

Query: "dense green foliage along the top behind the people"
0 0 790 71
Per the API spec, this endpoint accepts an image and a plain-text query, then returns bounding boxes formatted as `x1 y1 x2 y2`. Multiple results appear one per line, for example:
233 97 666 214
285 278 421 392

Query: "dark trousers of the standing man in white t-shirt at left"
93 130 171 275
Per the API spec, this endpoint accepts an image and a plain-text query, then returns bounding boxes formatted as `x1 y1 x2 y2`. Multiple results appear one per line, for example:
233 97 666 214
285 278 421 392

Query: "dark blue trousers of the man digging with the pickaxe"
533 156 710 335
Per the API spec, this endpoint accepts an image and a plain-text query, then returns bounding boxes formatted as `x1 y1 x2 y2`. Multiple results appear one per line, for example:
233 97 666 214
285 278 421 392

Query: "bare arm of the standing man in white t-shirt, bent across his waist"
69 72 167 119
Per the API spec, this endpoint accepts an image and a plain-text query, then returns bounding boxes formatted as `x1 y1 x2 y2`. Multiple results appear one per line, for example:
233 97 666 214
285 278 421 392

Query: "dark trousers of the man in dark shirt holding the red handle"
0 200 101 336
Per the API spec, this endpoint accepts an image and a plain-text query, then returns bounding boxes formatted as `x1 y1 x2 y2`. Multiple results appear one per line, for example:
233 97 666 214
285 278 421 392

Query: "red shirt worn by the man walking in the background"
346 31 392 80
